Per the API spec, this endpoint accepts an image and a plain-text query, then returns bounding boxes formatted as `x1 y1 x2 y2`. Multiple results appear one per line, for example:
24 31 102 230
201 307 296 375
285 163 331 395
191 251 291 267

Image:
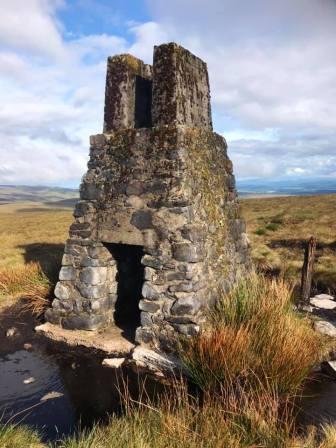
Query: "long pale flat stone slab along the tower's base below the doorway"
35 322 135 358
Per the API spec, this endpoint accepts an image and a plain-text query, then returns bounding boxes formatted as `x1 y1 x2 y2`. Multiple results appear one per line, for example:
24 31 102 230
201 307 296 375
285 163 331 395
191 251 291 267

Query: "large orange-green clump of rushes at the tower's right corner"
181 274 325 396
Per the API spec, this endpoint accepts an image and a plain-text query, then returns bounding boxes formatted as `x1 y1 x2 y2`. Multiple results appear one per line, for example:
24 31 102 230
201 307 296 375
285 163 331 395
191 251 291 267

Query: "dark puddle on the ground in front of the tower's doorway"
0 346 163 441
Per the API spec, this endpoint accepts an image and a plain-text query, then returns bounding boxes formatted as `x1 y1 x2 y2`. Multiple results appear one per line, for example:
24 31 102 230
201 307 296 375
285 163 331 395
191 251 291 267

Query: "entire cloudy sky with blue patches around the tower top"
0 0 336 187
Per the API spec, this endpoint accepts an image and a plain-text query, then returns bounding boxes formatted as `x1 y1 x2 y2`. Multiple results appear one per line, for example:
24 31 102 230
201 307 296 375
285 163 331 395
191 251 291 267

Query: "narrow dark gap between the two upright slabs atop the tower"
134 76 152 128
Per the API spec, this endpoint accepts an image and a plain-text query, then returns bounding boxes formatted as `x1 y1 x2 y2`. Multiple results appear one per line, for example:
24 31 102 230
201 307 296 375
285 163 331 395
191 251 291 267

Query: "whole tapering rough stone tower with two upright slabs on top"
46 43 250 350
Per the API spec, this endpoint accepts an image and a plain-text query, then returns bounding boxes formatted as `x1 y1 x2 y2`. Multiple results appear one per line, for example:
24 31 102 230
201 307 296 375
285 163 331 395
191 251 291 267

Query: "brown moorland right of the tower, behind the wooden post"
241 194 336 293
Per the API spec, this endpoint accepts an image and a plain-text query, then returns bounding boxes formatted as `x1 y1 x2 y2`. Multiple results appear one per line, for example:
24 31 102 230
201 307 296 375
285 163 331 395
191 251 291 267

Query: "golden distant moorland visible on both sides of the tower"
0 194 336 300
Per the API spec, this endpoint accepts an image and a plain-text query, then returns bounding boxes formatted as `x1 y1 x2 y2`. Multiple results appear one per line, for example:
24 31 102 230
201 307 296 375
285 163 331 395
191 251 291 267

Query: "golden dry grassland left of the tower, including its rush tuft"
0 203 72 315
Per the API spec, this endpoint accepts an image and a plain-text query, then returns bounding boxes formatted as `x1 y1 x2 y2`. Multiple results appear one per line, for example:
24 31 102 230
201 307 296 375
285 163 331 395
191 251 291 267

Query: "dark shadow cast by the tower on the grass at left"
18 243 64 283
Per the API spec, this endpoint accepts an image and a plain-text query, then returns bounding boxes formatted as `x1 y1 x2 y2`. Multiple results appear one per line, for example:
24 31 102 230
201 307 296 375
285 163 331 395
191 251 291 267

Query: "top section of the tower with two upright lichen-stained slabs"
104 43 212 132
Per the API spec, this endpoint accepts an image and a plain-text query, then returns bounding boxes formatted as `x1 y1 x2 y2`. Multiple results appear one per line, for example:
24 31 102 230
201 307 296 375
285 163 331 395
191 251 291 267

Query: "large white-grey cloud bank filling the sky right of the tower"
147 0 336 177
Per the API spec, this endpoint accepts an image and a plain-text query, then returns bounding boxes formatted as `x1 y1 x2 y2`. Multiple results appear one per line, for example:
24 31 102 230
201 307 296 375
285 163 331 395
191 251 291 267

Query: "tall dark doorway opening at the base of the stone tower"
106 243 144 336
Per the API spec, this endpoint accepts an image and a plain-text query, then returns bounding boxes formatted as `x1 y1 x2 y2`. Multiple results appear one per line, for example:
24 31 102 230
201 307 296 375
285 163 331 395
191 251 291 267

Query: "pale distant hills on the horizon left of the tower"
0 185 79 208
